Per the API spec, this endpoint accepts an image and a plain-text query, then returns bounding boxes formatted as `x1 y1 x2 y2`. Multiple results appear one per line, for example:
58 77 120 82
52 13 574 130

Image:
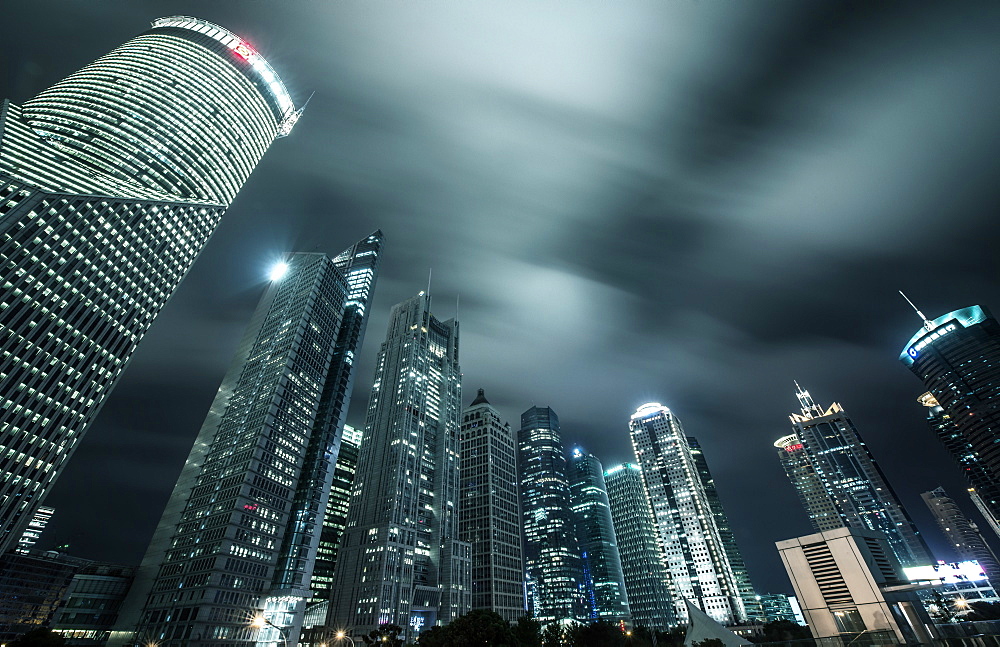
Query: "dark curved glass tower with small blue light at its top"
568 447 632 623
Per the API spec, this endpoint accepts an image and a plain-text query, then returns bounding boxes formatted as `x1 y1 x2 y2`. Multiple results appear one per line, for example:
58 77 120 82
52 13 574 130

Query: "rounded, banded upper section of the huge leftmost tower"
22 16 298 206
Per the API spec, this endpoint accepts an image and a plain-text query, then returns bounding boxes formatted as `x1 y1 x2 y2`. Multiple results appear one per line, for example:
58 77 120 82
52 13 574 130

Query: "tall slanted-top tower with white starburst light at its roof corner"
111 232 381 647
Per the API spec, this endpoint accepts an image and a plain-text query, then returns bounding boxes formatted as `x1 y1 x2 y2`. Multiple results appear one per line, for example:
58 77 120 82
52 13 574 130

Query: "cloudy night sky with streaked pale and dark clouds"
0 0 1000 593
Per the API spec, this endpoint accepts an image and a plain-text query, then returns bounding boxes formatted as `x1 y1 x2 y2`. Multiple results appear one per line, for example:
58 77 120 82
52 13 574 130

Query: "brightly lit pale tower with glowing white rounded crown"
629 402 746 623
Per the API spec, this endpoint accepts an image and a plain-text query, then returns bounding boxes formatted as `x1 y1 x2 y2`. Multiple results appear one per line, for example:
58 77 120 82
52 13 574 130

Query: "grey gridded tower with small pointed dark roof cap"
458 389 525 622
